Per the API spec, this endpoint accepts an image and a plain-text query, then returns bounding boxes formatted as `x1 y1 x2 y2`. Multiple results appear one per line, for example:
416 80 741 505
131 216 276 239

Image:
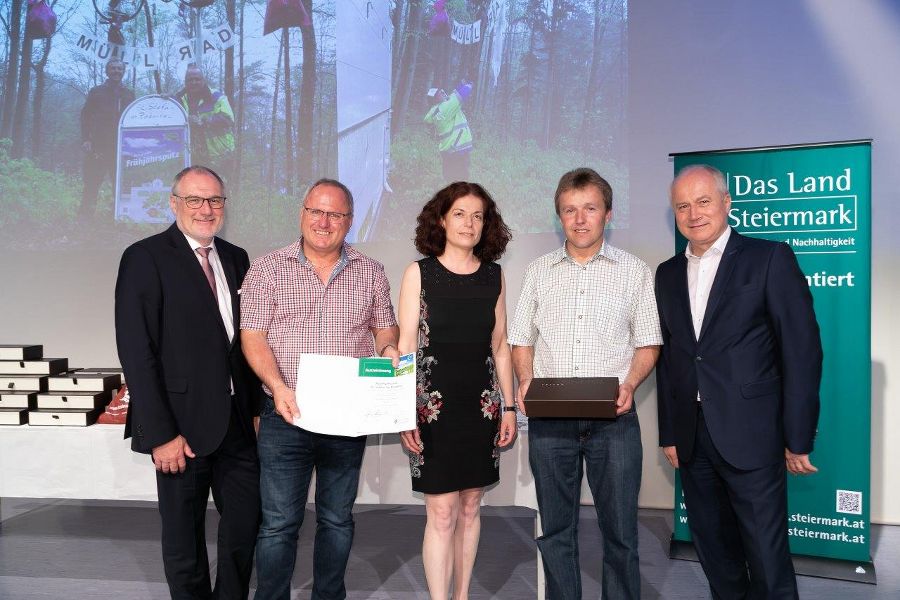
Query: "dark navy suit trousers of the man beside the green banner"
679 406 797 600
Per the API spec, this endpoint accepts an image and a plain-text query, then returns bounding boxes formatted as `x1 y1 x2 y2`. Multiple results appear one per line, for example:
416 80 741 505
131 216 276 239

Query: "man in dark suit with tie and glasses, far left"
116 166 262 598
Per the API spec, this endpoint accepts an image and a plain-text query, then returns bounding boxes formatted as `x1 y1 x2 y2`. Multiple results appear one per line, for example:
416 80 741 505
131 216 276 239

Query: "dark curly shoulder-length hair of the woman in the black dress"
416 181 512 262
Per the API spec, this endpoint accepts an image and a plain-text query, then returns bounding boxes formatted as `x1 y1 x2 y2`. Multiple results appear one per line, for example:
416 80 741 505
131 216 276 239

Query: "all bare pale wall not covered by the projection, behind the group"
0 0 900 523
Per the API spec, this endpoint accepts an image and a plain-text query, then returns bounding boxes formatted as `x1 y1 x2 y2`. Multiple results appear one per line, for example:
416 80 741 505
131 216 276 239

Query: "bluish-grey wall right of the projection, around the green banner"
618 0 900 523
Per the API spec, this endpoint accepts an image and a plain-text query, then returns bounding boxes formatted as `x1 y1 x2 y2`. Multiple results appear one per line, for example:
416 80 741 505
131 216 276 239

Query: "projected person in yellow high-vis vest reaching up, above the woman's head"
425 81 472 183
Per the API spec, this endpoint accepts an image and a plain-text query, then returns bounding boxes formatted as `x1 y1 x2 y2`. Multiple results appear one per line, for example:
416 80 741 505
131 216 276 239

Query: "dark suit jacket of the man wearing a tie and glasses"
116 224 262 456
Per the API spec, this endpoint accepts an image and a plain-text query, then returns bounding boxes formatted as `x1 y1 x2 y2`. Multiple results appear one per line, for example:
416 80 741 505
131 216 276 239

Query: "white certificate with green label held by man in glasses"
294 354 416 436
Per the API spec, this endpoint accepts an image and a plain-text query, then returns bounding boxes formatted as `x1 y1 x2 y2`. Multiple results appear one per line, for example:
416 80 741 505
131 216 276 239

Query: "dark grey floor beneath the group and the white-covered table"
0 498 900 600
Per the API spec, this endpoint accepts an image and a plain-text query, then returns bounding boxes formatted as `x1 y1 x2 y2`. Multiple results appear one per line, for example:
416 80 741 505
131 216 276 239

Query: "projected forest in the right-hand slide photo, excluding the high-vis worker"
389 0 628 237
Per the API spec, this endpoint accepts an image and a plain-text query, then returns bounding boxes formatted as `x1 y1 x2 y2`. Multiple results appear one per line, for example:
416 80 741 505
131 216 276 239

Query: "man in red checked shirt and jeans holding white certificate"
241 179 399 600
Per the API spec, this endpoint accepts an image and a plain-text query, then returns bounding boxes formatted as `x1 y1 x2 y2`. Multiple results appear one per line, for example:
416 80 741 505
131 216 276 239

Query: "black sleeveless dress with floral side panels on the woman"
410 257 502 494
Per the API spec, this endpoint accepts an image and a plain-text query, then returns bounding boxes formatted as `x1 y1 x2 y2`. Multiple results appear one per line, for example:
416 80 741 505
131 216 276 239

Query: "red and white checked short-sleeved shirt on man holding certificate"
241 238 396 395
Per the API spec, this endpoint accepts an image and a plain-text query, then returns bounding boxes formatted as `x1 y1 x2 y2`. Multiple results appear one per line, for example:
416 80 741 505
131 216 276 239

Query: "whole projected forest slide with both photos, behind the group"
0 0 628 249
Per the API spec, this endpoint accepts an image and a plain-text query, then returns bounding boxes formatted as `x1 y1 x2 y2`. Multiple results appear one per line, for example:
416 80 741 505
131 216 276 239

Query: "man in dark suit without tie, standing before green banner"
656 165 822 599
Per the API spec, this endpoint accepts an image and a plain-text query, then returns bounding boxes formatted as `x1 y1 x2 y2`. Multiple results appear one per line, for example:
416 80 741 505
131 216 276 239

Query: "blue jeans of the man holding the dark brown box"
528 410 643 600
